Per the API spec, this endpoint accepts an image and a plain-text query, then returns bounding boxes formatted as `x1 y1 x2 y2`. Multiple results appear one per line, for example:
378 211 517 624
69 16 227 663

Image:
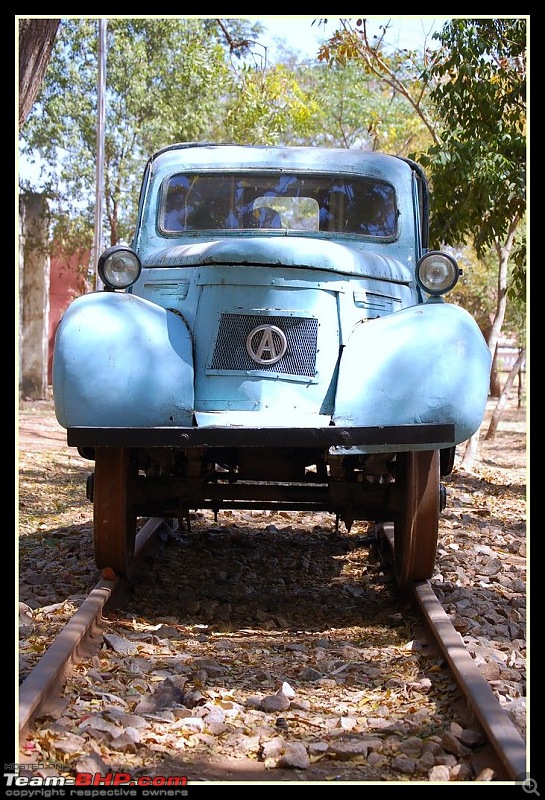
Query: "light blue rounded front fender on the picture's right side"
333 301 491 444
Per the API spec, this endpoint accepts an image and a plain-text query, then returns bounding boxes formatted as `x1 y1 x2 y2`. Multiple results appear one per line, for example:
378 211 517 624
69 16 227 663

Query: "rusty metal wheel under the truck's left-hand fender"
93 447 137 577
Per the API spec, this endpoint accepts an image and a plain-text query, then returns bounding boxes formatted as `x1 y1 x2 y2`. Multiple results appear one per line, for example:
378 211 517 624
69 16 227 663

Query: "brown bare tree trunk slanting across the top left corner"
19 19 60 128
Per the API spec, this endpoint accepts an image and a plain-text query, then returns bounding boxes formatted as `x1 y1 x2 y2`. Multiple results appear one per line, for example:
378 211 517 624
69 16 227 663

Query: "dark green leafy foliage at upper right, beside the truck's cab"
421 19 526 266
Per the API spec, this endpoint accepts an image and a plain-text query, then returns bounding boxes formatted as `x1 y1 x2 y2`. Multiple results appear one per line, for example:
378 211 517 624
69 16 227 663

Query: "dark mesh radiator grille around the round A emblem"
210 314 318 378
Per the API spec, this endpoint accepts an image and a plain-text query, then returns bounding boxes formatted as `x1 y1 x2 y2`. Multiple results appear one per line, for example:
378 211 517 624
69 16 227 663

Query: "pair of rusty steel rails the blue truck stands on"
19 518 527 781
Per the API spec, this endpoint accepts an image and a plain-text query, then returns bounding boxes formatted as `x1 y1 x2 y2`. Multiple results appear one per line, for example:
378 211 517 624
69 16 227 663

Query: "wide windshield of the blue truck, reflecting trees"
159 173 397 238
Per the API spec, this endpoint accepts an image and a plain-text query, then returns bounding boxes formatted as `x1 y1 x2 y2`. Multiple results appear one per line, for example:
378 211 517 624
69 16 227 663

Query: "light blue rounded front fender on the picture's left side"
53 292 194 428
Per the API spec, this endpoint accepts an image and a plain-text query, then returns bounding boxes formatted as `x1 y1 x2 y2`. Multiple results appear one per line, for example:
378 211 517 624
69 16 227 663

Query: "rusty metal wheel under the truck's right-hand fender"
394 450 441 589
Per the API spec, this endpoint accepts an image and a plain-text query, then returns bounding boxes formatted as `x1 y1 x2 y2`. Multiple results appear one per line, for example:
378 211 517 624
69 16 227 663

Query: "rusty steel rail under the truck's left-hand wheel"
18 517 164 737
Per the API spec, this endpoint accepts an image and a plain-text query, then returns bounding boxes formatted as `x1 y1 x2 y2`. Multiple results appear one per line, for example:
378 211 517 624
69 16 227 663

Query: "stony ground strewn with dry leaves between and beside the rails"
18 394 526 783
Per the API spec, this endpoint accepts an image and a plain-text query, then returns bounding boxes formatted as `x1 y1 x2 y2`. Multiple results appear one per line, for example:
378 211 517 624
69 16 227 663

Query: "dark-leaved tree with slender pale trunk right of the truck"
320 18 527 467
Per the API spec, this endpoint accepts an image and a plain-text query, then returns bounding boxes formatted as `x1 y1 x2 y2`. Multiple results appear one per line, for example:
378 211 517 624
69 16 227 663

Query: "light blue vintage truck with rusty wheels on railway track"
53 143 491 587
